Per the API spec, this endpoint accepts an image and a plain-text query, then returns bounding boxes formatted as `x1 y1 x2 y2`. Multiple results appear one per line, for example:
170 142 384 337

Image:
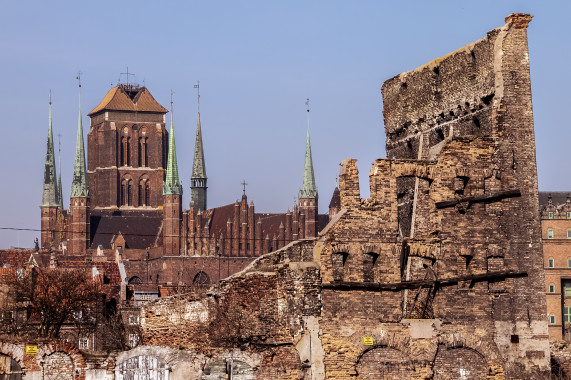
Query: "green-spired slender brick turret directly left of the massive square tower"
68 76 89 255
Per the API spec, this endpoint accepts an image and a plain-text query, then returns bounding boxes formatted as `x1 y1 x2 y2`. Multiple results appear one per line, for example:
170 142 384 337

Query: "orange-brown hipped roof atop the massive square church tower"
88 84 168 116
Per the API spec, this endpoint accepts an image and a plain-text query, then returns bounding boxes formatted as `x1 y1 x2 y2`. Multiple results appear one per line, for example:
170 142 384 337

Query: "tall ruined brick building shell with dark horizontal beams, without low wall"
318 11 549 379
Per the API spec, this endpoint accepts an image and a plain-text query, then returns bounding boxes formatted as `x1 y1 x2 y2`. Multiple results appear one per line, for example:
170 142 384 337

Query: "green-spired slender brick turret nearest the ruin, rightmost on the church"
299 99 318 238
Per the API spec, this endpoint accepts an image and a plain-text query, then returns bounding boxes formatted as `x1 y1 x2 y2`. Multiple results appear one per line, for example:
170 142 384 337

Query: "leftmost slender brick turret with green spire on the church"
40 93 60 249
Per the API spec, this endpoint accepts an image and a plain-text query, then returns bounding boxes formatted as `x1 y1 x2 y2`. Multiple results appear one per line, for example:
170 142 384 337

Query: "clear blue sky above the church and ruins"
0 0 571 248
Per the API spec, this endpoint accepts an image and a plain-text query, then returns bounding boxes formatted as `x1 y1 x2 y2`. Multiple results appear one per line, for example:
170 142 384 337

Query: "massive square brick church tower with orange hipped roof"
87 84 168 211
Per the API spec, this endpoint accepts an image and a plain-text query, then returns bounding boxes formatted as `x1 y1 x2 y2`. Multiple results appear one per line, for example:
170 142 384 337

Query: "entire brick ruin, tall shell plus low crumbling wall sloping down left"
134 14 550 379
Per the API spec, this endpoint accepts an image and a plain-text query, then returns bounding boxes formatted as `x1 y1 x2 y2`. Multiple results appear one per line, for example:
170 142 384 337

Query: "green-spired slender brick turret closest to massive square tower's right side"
163 93 182 256
